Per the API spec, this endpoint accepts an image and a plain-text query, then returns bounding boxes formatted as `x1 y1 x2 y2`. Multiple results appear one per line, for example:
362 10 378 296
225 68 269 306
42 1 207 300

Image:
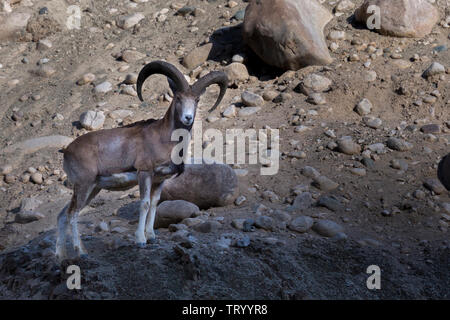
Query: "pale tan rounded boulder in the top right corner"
355 0 439 38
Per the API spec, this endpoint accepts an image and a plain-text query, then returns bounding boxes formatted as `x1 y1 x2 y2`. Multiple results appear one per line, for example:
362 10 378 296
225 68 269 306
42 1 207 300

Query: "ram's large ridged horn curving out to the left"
136 61 189 101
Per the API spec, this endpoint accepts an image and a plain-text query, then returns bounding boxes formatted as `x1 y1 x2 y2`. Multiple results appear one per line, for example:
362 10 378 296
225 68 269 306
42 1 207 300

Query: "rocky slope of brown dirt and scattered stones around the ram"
0 0 450 299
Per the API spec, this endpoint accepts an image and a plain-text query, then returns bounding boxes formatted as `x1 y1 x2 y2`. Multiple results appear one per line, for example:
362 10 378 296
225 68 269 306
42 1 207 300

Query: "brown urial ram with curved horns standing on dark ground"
56 61 228 260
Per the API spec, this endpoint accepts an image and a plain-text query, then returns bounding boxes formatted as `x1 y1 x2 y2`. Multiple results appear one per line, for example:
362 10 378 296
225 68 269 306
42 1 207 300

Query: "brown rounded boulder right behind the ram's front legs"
161 163 238 209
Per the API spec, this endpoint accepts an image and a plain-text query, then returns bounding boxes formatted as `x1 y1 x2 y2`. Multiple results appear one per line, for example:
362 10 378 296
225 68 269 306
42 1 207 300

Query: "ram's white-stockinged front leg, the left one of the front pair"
135 172 152 248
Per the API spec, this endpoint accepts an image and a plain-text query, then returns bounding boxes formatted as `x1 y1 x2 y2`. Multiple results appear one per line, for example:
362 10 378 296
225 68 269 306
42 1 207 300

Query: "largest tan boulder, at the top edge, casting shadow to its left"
243 0 333 70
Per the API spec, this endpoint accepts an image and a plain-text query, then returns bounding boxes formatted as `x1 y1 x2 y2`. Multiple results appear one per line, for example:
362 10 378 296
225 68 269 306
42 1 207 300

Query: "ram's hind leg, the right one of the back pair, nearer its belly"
68 183 101 257
